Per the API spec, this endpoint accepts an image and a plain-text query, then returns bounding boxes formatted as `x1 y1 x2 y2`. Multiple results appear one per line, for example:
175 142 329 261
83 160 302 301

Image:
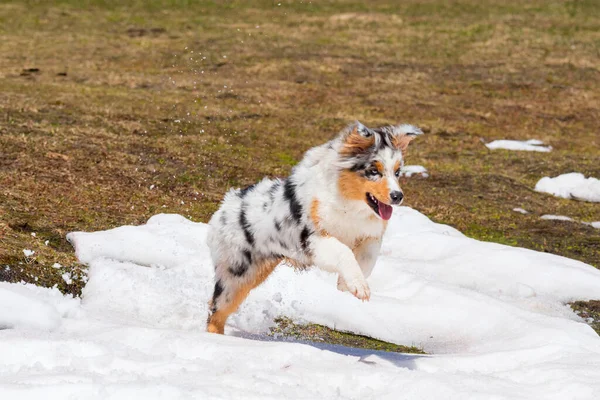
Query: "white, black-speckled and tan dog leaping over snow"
207 121 422 334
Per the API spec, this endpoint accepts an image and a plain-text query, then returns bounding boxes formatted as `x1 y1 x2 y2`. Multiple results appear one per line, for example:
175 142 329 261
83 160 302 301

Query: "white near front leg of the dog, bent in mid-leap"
310 236 371 300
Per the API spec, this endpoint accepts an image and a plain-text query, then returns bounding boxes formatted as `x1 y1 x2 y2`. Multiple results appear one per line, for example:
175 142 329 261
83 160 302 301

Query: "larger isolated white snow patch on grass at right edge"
535 172 600 202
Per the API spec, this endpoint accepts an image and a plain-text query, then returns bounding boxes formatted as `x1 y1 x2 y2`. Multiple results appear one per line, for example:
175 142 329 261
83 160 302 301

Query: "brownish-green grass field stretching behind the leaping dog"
0 0 600 344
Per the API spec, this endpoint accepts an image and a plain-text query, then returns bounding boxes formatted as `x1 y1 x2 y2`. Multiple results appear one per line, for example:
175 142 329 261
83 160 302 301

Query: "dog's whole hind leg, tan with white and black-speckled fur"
206 258 281 334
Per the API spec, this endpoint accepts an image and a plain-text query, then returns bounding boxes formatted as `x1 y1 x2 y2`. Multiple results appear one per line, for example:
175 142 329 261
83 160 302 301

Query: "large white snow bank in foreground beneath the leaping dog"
0 207 600 400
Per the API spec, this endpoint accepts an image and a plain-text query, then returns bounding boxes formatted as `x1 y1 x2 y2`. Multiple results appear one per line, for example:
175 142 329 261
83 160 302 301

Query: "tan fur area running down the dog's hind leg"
206 258 282 334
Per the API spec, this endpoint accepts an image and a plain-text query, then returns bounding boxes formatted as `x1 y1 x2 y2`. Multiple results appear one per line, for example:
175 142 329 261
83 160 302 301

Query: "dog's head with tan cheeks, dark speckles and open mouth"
338 122 423 220
